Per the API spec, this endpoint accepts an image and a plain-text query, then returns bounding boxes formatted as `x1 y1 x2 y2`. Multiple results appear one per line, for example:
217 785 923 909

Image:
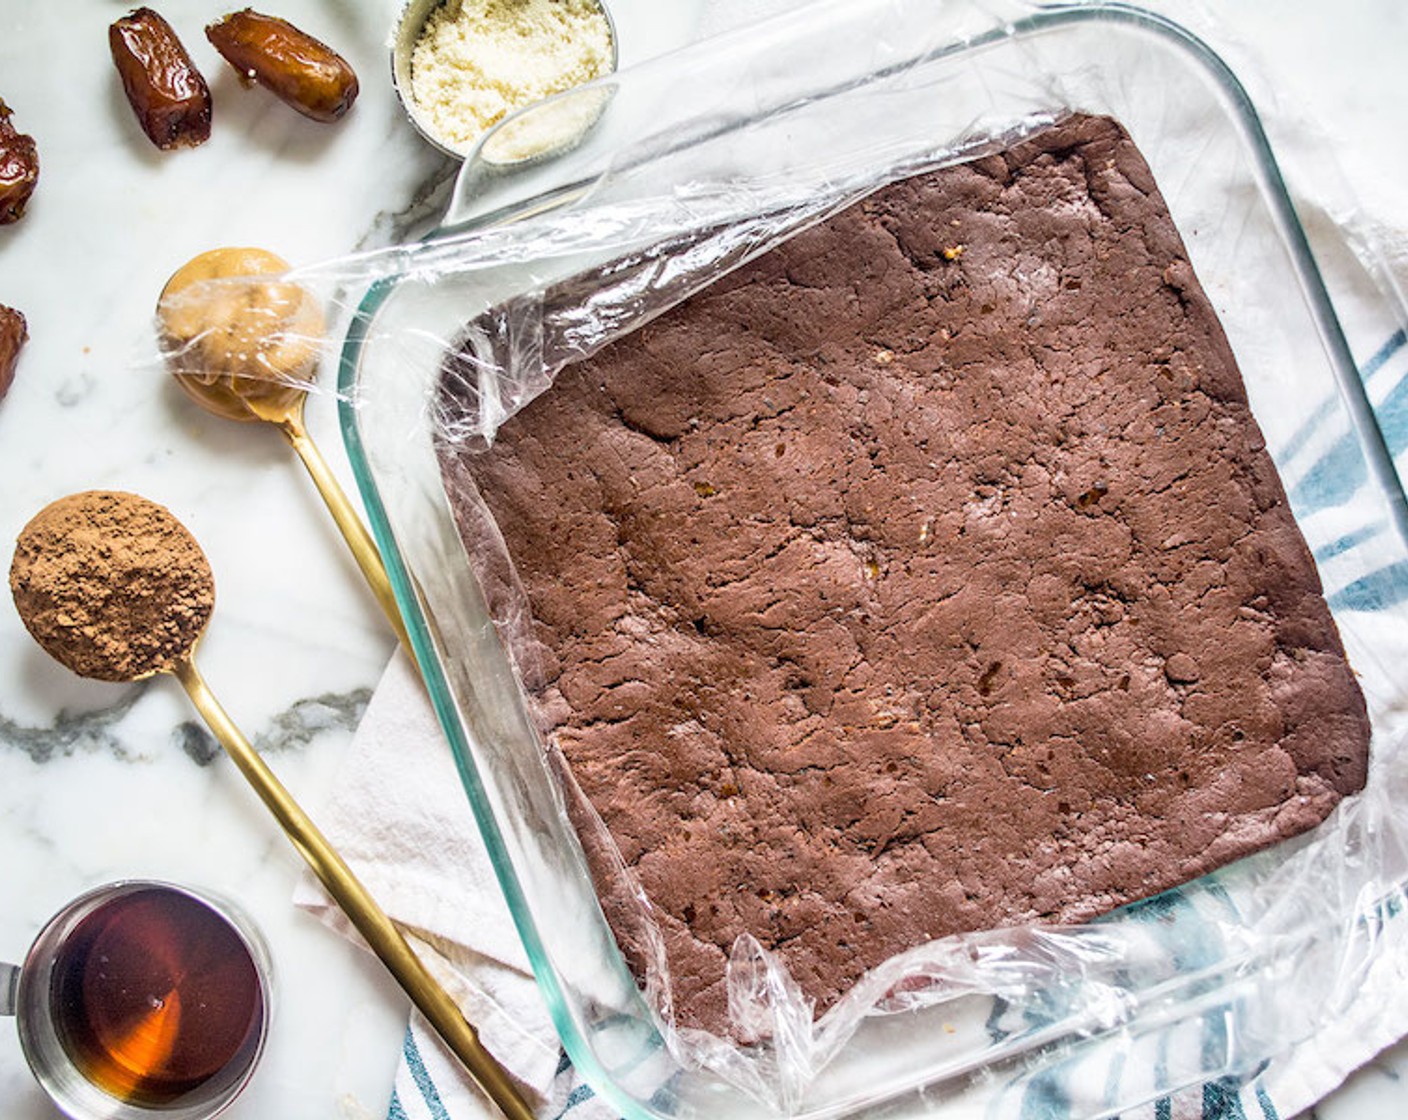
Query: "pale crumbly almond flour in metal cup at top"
411 0 612 151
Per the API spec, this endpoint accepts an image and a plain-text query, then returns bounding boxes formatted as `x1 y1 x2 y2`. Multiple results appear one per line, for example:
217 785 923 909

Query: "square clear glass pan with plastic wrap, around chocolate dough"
339 0 1408 1117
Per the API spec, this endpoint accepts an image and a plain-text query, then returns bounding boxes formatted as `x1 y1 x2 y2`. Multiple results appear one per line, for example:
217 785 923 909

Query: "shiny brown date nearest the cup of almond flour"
206 8 358 124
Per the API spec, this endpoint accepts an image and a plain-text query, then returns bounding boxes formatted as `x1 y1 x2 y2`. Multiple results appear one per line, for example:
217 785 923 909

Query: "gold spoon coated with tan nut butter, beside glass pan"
156 248 411 651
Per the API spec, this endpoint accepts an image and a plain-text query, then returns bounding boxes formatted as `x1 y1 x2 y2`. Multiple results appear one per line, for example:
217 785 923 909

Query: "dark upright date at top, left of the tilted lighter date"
107 8 211 151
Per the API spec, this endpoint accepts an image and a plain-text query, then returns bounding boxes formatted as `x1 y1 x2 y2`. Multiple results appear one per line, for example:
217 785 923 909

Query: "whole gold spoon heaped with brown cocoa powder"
10 490 532 1120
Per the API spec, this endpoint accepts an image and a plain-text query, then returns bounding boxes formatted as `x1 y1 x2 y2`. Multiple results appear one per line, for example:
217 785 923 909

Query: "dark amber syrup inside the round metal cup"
49 886 265 1107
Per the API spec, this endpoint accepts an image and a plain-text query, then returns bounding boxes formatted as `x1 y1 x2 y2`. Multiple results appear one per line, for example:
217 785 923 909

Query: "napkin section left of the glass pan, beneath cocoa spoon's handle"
294 651 610 1120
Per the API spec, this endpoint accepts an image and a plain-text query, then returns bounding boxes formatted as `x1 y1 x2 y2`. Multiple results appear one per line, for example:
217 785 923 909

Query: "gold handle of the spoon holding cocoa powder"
172 654 534 1120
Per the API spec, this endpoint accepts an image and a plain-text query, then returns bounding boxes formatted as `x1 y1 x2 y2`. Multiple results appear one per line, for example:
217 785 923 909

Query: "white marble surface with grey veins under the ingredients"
0 0 1408 1120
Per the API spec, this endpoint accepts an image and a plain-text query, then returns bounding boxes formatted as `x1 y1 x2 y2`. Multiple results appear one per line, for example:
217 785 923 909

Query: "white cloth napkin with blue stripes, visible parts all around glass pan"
296 0 1408 1120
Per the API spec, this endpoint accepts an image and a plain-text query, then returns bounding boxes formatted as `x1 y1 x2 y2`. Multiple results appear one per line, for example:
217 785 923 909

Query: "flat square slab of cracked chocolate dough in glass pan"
449 117 1369 1030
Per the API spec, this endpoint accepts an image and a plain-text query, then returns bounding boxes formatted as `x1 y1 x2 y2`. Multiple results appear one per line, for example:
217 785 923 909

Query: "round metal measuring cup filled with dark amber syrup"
0 881 269 1120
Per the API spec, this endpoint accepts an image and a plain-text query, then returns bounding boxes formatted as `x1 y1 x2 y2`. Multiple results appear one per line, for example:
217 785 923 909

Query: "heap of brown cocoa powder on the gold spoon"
10 490 215 680
